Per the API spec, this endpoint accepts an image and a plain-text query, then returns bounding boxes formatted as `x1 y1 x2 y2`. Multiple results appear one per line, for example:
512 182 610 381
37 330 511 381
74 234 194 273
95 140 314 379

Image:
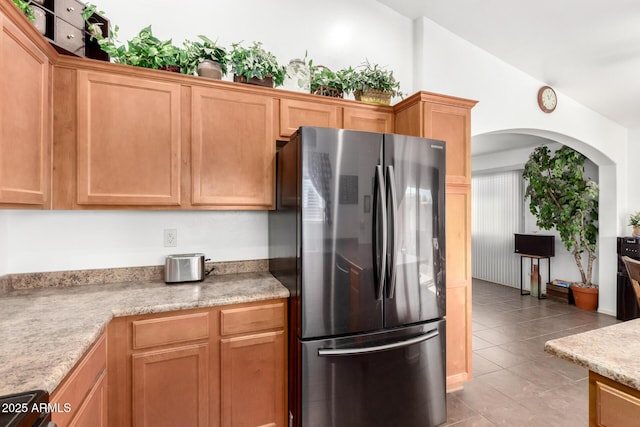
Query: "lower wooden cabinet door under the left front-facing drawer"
132 343 209 427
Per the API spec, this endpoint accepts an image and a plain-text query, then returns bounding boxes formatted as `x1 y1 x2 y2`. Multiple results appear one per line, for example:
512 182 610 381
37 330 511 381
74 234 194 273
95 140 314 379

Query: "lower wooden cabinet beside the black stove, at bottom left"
51 334 108 427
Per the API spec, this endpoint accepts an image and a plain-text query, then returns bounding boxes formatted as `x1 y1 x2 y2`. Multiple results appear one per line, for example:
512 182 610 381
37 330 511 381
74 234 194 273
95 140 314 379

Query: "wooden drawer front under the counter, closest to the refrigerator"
220 303 284 336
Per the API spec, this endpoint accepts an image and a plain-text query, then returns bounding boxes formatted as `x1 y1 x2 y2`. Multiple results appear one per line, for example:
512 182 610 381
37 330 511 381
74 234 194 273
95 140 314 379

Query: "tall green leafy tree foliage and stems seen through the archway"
522 146 598 288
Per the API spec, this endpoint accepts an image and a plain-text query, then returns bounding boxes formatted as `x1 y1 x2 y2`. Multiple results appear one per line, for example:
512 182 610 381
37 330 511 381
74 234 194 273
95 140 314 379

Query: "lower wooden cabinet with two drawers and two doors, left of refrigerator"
107 300 287 427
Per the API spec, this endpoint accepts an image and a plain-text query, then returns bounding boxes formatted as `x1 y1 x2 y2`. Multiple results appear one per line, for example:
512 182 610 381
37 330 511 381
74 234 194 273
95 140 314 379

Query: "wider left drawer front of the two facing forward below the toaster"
132 312 209 350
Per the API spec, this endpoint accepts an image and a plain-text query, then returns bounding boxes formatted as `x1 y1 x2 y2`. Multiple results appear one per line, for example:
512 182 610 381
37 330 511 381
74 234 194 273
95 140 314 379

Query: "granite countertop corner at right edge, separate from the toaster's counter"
544 319 640 390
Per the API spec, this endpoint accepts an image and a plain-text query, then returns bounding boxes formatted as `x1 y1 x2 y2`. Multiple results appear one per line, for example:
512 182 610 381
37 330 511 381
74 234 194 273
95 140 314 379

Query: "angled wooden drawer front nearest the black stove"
51 334 107 427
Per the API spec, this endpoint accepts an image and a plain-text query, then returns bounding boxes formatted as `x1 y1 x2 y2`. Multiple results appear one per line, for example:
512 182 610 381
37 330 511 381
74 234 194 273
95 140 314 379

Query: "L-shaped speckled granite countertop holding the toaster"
0 272 289 395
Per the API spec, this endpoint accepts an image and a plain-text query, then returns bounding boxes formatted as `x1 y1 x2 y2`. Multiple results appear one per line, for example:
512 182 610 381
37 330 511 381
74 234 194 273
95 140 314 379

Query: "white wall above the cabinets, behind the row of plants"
93 0 415 101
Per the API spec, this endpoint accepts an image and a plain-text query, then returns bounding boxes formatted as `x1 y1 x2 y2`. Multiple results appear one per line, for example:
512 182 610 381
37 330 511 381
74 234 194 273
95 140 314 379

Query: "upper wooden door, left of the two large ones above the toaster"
77 70 181 206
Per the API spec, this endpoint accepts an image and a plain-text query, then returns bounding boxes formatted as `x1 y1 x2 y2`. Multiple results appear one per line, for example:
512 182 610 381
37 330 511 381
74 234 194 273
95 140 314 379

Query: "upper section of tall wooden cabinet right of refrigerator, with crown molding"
394 92 476 184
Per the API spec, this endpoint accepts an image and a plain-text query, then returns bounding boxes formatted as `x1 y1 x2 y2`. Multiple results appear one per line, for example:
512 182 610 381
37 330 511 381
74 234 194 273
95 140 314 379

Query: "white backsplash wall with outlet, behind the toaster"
0 211 268 276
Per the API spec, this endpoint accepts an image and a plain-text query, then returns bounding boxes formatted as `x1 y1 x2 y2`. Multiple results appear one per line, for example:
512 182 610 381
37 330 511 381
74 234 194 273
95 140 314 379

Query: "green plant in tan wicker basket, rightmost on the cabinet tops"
347 61 402 105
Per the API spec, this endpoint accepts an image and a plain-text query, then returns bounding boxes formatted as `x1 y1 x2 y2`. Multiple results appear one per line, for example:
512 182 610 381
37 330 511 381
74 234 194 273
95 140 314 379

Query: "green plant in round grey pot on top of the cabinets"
183 35 228 80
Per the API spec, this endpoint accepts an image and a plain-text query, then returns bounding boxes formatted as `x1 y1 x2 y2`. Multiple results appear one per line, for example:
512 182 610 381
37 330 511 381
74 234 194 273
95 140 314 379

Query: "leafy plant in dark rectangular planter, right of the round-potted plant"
229 42 286 87
